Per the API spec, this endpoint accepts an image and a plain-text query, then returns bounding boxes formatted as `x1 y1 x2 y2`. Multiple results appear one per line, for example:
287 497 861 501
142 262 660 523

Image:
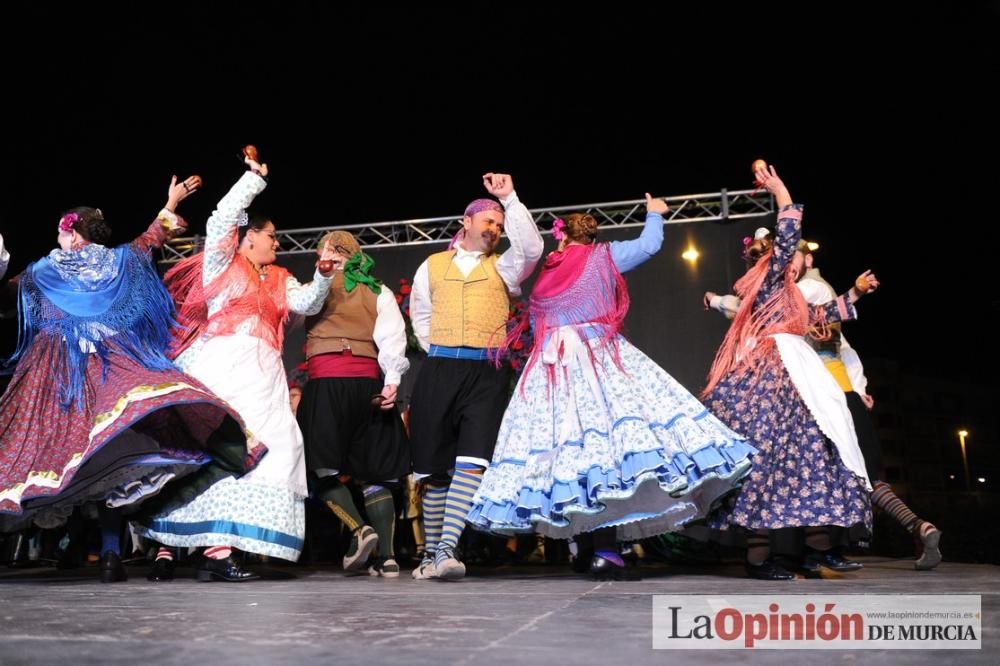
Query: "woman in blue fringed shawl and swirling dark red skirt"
0 176 263 582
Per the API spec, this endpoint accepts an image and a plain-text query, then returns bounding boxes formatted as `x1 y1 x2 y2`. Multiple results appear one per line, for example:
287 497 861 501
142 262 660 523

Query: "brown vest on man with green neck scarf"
306 271 378 358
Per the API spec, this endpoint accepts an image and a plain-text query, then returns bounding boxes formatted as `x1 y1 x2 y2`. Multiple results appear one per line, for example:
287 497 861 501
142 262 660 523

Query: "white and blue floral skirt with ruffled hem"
468 327 754 540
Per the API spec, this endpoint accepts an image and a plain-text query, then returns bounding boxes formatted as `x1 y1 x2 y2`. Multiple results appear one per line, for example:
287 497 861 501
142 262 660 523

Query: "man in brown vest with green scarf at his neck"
299 231 410 578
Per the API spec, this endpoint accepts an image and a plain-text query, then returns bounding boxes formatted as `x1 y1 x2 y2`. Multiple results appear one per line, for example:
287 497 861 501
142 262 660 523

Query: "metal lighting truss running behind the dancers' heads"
160 185 774 264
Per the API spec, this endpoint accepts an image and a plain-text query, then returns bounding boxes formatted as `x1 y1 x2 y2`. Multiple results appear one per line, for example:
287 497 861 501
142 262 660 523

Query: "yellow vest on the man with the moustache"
427 250 510 349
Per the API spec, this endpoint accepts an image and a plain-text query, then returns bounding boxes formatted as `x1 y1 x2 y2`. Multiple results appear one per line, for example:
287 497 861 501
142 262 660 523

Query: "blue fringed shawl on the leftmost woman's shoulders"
10 245 176 410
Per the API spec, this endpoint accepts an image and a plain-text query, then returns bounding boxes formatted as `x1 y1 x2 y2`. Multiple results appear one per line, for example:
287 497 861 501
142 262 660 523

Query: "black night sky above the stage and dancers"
0 2 1000 381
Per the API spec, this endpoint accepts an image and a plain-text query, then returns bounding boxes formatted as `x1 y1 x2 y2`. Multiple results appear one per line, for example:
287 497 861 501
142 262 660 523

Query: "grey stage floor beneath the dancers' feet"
0 557 1000 666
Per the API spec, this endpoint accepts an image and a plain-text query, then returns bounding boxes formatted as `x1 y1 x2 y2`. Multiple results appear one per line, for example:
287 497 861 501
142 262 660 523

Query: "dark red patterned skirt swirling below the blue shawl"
0 335 266 530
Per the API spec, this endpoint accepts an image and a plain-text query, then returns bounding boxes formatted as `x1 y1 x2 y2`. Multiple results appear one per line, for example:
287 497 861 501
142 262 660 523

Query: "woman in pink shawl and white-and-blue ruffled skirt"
469 194 754 579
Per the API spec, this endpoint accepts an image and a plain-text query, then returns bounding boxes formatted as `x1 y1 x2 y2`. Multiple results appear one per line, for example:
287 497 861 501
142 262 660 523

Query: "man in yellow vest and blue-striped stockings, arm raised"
410 173 543 580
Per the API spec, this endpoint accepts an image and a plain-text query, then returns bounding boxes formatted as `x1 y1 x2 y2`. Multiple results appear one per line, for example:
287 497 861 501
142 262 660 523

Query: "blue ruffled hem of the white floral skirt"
467 439 757 540
